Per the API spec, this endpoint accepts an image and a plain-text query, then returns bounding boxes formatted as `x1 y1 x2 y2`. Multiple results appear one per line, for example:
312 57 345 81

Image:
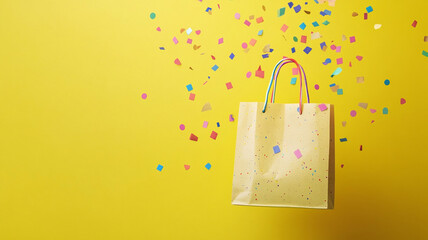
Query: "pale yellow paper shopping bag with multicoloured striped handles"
232 58 334 209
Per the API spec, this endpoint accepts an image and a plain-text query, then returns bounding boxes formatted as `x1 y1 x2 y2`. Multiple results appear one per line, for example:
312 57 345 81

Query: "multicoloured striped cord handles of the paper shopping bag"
262 57 310 115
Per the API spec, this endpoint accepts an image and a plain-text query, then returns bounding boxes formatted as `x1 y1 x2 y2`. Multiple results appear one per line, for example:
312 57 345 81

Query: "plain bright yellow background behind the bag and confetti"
0 0 428 240
